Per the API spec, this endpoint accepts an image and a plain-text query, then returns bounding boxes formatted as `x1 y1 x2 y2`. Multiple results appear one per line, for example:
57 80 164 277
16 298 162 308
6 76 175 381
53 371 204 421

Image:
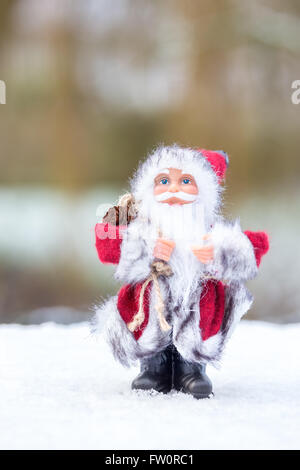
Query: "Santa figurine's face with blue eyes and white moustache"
154 168 198 205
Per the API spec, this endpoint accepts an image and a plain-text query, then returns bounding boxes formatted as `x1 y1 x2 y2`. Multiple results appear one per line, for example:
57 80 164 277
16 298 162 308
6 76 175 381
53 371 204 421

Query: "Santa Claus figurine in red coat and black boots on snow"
93 145 269 398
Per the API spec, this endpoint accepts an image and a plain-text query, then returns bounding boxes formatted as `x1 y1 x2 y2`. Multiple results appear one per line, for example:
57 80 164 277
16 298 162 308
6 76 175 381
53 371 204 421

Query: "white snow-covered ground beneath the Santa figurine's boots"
0 321 300 449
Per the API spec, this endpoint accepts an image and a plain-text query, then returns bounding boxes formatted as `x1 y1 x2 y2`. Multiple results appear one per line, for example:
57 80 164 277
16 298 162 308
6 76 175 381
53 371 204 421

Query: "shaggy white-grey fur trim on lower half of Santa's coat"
92 280 252 367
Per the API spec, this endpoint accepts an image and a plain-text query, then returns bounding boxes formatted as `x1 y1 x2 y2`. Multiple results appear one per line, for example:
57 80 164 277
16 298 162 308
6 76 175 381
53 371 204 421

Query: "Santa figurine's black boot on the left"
131 346 172 393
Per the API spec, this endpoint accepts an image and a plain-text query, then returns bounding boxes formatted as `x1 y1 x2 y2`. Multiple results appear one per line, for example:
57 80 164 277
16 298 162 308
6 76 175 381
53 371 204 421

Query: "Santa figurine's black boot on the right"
173 347 212 399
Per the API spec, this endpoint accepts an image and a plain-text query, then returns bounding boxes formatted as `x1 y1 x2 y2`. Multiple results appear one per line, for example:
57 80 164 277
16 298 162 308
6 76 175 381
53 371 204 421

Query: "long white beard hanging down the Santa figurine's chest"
139 197 207 308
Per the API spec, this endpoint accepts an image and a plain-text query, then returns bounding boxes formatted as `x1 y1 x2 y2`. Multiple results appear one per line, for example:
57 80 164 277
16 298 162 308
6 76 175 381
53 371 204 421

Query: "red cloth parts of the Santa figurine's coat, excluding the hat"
95 223 269 341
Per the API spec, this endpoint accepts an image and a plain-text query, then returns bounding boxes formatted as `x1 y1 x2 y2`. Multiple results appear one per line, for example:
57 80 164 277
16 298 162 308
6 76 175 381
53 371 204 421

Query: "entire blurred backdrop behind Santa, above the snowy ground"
0 0 300 324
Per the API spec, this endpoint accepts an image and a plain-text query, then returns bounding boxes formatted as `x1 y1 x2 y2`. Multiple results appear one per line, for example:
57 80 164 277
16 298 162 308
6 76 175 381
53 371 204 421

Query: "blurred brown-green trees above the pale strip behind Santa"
0 0 300 194
